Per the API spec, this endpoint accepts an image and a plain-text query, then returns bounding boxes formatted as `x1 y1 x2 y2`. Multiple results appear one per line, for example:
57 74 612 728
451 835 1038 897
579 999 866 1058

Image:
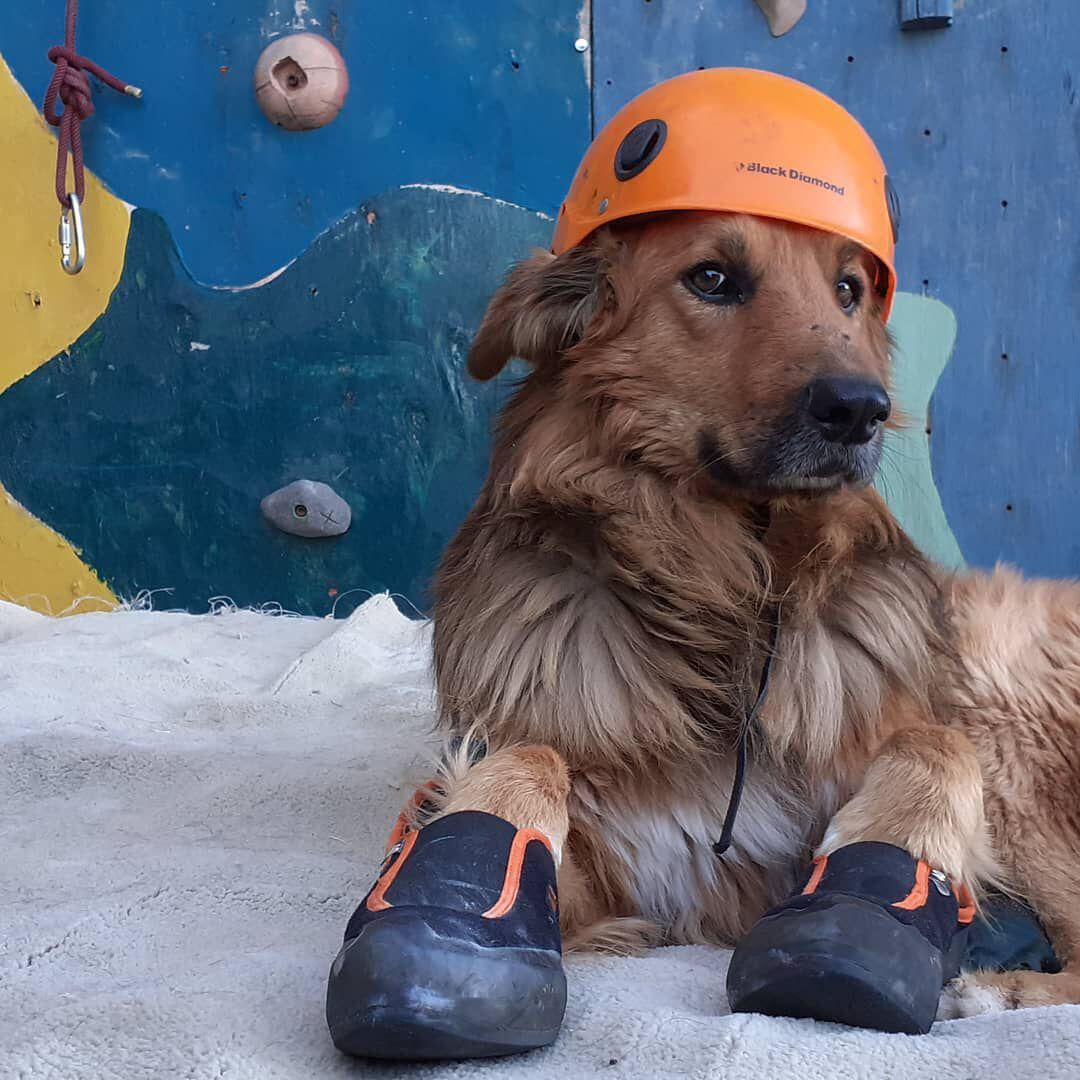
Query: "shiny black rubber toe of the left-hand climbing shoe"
326 912 566 1061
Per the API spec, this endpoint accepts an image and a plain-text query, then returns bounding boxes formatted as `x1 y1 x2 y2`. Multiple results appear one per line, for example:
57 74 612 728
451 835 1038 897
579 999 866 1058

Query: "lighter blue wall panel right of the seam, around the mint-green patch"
593 0 1080 576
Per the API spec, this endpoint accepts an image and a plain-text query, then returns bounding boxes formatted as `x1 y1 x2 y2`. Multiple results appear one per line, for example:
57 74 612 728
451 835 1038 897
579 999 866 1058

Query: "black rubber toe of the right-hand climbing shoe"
727 896 945 1035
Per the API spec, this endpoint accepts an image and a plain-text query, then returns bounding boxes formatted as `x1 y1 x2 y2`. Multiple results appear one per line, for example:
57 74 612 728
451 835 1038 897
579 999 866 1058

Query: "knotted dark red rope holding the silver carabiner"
42 0 143 208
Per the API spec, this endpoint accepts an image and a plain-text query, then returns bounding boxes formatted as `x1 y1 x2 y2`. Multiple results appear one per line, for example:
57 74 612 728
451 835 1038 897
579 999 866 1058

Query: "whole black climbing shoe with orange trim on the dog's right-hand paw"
728 841 974 1035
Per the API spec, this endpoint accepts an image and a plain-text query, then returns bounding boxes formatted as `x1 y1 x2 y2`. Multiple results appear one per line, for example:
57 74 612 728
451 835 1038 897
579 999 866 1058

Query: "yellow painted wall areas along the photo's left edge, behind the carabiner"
0 56 131 613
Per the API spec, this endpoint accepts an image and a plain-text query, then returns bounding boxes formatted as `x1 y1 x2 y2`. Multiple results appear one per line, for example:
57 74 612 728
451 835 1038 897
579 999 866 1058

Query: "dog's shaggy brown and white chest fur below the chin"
436 495 936 942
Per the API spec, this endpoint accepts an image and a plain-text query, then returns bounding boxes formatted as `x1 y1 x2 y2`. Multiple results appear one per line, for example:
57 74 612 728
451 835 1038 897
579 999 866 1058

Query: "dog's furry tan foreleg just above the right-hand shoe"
818 727 997 893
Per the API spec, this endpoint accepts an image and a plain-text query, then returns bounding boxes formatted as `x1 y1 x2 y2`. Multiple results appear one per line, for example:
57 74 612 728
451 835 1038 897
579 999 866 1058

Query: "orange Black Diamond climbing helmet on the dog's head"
552 68 900 319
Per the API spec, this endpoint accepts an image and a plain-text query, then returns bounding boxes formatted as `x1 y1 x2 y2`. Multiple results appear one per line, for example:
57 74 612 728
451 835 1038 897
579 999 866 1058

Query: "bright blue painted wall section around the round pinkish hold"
0 0 590 285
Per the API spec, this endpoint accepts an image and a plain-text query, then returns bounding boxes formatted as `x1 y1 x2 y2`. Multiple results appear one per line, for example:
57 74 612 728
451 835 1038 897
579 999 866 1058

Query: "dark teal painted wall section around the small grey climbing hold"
0 189 550 615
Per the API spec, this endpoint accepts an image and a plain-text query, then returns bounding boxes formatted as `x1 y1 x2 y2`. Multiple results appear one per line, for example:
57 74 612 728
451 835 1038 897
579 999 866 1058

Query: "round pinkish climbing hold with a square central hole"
255 33 349 131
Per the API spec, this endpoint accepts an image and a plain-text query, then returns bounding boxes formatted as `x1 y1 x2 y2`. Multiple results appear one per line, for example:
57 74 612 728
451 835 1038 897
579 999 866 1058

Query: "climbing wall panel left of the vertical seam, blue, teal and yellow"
0 0 590 616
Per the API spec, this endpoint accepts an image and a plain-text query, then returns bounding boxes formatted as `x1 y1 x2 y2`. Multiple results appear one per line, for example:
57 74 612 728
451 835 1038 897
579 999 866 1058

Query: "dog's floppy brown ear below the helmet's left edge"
469 244 611 379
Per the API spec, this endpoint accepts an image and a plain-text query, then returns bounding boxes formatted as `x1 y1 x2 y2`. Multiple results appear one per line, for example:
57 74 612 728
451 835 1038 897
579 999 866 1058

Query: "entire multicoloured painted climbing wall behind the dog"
0 0 1080 616
